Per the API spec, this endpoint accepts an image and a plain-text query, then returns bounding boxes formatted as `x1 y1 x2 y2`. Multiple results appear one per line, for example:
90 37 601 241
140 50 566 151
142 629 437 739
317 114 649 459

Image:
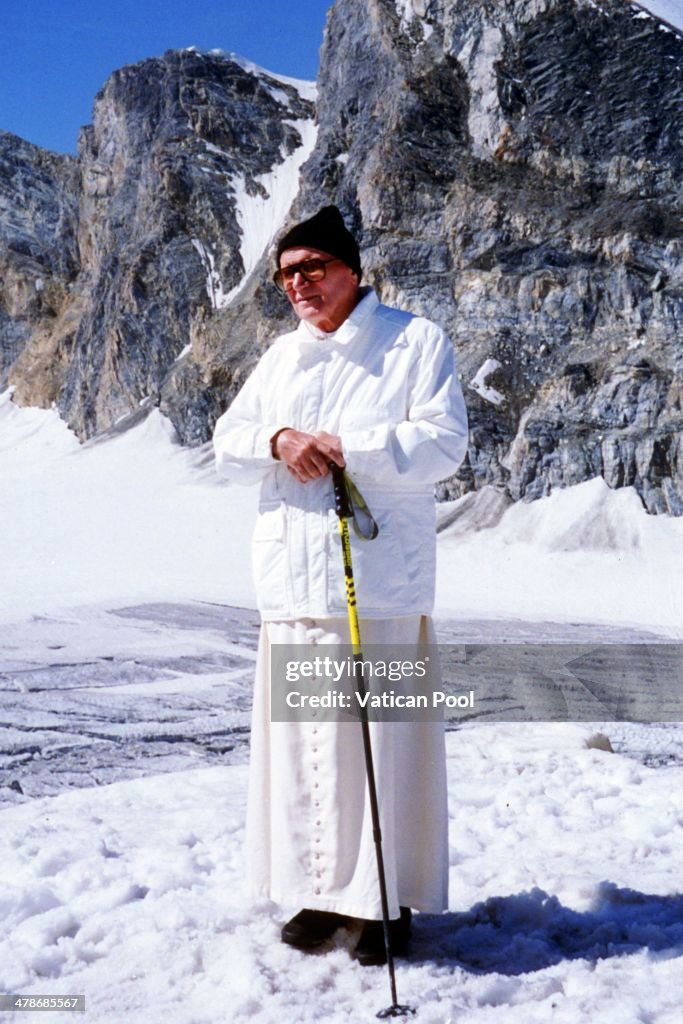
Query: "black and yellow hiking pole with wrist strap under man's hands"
330 463 415 1019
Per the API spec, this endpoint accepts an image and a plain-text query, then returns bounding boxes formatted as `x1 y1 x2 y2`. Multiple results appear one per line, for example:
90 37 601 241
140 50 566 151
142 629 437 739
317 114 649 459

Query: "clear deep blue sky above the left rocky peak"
0 0 332 153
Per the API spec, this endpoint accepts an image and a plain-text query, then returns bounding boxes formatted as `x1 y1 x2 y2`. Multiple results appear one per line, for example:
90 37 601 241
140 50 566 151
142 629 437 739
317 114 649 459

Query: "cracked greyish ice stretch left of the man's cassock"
0 602 258 805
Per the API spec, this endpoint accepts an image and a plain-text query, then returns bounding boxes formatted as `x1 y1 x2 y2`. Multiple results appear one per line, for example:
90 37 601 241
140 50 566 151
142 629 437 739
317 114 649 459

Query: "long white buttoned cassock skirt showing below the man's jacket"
247 615 449 919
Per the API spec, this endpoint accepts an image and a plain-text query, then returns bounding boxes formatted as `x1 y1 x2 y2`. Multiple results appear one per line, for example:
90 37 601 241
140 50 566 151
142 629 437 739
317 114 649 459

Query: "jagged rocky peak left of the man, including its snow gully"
0 50 314 443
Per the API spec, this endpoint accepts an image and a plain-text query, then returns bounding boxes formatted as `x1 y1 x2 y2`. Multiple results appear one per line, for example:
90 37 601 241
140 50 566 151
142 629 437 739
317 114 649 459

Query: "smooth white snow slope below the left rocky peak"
0 392 256 623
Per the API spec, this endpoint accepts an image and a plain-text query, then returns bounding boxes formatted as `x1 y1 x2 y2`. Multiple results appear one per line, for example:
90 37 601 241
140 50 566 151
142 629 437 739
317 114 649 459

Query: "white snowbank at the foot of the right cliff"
436 477 683 639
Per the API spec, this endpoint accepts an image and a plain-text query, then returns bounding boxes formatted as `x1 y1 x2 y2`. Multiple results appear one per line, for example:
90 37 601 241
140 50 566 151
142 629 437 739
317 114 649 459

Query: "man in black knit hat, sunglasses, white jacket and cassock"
214 206 467 964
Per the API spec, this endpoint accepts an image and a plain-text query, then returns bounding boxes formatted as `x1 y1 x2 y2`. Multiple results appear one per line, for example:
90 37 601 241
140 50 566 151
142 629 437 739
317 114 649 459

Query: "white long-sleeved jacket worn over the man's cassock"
214 290 467 620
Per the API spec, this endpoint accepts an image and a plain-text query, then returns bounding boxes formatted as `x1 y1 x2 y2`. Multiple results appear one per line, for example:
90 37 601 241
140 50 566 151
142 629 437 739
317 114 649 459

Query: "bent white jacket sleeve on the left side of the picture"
213 359 282 484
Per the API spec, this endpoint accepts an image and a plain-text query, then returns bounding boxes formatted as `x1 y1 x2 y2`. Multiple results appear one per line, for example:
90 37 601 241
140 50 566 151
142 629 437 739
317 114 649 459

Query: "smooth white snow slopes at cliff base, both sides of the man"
0 391 683 638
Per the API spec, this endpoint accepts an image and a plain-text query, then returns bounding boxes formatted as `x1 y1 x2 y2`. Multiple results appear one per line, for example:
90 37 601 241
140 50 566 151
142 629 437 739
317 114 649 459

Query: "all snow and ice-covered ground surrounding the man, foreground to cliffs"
0 393 683 1024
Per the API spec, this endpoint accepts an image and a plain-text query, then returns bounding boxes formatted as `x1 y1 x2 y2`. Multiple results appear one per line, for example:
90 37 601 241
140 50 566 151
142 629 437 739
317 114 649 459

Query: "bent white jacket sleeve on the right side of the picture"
342 321 468 486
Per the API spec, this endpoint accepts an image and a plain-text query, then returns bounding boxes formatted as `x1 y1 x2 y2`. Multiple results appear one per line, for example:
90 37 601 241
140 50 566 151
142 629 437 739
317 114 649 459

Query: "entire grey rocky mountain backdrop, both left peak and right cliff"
0 0 683 515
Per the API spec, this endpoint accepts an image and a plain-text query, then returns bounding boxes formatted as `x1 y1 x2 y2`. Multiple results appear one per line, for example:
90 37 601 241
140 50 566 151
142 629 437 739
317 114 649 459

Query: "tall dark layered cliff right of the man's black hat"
299 0 683 514
